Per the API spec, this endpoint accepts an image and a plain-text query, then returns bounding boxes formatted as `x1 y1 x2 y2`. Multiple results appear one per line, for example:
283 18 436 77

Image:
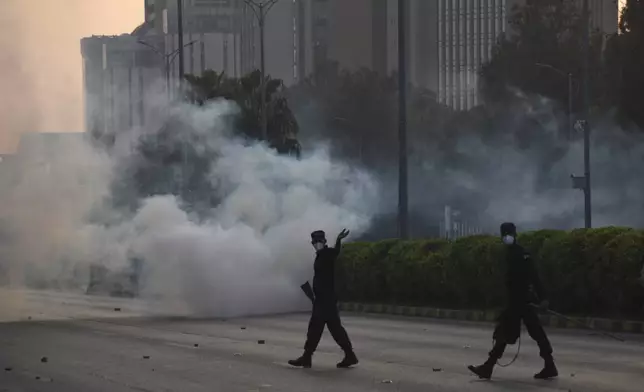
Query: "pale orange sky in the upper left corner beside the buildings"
0 0 143 153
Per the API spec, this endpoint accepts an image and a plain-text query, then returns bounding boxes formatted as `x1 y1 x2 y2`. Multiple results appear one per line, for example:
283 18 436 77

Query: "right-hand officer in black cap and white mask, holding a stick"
468 223 558 379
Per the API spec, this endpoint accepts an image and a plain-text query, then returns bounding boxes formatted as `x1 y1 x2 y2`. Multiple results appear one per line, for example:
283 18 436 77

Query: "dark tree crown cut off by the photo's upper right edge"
605 0 644 130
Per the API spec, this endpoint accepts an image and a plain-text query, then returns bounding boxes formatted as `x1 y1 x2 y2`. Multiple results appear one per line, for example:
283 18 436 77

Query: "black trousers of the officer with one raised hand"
304 299 352 355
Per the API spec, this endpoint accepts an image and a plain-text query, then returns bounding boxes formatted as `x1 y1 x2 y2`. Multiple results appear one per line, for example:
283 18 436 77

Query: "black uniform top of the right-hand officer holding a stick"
506 244 546 306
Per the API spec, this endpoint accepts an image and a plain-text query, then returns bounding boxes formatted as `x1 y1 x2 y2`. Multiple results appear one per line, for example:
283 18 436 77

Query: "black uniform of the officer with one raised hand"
304 243 352 355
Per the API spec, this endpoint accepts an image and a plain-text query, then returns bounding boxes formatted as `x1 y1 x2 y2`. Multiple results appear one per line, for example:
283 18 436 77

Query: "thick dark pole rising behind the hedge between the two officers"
398 0 409 239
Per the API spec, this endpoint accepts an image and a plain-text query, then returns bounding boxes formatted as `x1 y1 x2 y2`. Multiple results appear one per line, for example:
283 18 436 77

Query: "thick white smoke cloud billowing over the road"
0 102 378 316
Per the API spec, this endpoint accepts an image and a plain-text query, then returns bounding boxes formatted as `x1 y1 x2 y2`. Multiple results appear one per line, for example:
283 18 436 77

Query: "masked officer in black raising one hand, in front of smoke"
288 229 358 368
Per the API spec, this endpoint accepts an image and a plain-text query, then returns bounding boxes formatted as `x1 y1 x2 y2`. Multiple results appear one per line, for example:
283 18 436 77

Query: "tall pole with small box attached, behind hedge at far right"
582 0 592 229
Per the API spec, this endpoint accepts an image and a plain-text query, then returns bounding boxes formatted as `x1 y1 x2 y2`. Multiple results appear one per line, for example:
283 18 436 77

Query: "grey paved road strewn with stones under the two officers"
0 294 644 392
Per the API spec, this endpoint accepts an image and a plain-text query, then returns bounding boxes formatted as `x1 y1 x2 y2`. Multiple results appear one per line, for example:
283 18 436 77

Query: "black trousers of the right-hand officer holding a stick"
490 305 552 360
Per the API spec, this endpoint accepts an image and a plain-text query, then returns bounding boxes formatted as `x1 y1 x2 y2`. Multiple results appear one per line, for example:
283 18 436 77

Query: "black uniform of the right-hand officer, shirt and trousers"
490 244 552 360
